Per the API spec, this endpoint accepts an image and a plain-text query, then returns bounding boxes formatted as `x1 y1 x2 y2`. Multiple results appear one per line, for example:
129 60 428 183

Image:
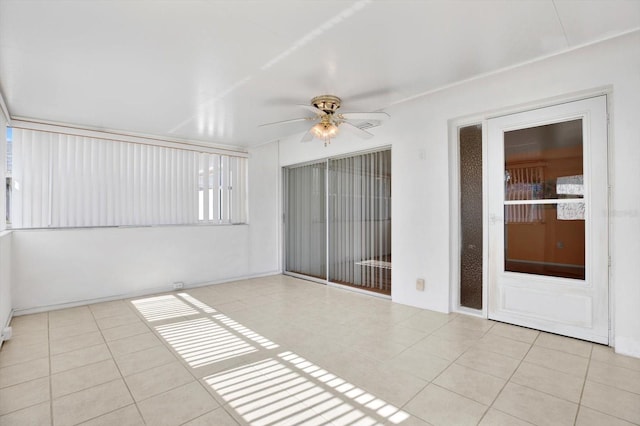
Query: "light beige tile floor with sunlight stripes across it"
0 276 640 426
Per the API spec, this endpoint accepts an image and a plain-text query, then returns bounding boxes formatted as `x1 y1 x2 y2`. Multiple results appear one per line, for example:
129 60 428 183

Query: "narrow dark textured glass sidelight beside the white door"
460 126 482 309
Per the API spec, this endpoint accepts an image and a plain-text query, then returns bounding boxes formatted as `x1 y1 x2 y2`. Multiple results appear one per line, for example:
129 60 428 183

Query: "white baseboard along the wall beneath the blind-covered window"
12 271 282 316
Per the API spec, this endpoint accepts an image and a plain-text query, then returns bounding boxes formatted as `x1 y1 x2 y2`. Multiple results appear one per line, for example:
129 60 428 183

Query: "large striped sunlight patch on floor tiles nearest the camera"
204 352 409 425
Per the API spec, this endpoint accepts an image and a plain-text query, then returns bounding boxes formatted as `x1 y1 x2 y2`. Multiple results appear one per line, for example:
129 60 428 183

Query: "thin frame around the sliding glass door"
281 145 393 300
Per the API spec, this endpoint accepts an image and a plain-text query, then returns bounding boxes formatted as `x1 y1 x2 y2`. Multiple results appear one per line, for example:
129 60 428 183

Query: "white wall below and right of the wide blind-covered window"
10 141 280 314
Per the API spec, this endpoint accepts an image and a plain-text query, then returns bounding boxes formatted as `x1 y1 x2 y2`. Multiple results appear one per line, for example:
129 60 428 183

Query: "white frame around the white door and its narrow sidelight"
448 86 615 346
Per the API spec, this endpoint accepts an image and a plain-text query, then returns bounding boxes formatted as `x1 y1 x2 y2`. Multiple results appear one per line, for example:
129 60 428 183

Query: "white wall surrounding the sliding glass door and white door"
274 31 640 356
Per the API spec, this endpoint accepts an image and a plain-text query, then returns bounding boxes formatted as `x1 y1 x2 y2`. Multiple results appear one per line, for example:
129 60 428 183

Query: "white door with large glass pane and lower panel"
487 96 609 344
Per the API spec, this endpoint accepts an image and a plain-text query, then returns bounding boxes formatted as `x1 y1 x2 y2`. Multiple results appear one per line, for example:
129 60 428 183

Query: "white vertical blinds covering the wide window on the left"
11 128 246 228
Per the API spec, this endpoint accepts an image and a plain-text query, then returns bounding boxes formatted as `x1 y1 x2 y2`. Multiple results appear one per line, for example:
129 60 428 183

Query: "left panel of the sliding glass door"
285 162 327 279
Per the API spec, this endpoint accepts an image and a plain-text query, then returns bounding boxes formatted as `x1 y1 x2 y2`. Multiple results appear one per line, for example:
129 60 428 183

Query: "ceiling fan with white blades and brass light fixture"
260 95 389 146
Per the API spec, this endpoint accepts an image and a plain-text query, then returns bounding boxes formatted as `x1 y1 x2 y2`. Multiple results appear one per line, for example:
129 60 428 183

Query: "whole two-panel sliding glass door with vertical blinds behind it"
285 150 391 295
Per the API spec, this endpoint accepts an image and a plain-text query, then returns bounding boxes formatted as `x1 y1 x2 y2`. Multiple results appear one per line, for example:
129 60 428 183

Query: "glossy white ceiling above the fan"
0 0 640 147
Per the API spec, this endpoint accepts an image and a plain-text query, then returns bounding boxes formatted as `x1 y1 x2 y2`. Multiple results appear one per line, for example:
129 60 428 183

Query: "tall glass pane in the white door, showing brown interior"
504 119 585 279
